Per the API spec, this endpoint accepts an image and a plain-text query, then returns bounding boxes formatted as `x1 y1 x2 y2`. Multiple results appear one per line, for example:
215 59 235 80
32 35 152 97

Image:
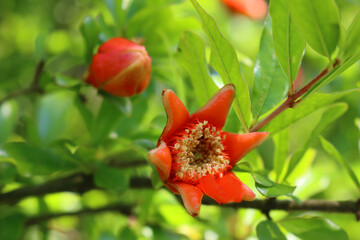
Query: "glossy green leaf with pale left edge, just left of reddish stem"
251 18 289 120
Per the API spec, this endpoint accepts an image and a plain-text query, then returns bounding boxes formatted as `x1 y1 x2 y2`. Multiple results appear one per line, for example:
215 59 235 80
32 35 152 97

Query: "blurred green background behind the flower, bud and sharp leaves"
0 0 360 240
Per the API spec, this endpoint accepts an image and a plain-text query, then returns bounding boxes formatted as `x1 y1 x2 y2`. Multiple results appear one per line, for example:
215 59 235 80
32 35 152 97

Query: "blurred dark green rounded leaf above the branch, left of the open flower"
94 164 130 194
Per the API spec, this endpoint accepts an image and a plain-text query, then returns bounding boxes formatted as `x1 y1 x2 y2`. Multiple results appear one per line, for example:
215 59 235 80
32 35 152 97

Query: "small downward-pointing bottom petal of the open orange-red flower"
173 183 203 217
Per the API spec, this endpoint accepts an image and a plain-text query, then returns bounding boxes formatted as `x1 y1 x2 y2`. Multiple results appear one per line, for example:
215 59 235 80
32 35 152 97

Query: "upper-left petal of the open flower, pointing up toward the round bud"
159 89 189 142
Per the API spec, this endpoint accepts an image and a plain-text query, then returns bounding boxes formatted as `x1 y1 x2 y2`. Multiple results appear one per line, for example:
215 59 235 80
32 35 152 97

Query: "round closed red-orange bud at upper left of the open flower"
86 38 151 97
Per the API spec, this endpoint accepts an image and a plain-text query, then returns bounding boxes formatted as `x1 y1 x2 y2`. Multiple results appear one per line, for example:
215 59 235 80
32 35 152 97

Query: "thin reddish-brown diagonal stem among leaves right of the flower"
250 60 340 132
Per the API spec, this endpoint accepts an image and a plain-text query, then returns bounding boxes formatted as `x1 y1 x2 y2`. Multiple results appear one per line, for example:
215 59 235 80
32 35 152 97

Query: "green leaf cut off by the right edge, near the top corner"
340 11 360 60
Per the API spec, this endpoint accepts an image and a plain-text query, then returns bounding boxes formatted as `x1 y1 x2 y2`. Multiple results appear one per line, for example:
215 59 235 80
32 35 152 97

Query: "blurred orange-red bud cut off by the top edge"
222 0 267 19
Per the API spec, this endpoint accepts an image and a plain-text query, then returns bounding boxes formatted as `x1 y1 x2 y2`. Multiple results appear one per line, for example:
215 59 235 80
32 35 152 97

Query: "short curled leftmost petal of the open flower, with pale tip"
147 141 171 181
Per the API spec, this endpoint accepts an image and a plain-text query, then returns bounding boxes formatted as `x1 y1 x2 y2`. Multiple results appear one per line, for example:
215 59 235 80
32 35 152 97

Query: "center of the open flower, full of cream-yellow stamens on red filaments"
170 121 231 183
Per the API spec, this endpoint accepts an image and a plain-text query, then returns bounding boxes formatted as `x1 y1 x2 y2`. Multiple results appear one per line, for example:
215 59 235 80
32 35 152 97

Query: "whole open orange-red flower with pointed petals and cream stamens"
148 84 268 216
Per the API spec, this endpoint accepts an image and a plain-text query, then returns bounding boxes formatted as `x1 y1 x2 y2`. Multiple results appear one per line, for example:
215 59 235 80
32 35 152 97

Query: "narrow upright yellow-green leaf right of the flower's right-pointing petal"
273 128 289 181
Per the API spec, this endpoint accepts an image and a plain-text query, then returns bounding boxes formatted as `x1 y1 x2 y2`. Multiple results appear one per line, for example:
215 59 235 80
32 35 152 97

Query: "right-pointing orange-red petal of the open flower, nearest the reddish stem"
224 132 269 166
